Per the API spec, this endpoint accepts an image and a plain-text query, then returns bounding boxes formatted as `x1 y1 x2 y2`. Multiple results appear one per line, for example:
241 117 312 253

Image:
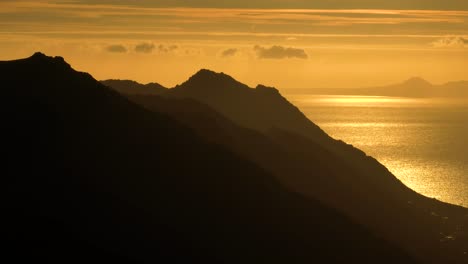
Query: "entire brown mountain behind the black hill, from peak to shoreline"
106 70 468 263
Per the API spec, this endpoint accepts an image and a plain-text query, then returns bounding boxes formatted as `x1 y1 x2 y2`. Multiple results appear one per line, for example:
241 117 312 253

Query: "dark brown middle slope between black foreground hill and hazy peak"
129 96 468 263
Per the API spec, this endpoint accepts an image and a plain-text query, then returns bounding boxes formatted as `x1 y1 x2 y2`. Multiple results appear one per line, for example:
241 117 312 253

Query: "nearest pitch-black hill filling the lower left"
0 53 413 263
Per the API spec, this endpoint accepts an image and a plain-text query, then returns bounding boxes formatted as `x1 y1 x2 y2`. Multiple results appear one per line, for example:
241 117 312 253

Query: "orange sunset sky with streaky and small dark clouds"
0 0 468 90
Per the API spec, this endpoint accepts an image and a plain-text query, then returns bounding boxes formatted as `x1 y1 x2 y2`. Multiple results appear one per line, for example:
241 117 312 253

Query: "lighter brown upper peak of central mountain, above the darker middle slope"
163 70 326 137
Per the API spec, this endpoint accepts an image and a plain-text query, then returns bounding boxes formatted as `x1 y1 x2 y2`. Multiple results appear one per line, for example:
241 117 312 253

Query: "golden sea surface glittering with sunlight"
286 94 468 207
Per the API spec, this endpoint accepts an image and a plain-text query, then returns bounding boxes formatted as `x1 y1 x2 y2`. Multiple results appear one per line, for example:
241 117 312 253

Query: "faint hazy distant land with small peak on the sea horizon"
291 77 468 98
